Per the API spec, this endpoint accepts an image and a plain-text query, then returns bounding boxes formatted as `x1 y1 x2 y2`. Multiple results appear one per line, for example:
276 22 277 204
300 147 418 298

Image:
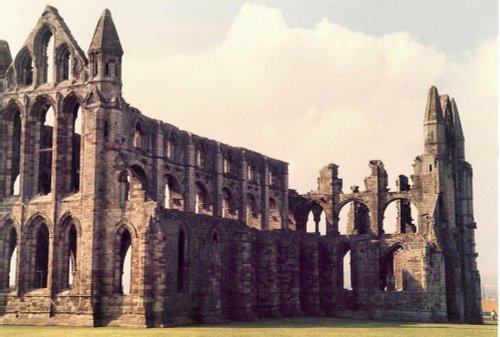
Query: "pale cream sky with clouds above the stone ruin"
0 0 498 286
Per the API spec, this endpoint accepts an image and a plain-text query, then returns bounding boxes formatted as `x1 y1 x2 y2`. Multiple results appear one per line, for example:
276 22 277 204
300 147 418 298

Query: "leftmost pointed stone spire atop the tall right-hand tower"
424 86 446 155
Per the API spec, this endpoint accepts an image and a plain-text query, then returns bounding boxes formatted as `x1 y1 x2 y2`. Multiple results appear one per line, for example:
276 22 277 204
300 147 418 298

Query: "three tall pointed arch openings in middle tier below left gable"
4 93 84 196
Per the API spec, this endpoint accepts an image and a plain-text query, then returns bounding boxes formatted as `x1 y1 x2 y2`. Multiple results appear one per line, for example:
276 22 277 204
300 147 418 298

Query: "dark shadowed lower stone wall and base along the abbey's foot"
0 210 446 327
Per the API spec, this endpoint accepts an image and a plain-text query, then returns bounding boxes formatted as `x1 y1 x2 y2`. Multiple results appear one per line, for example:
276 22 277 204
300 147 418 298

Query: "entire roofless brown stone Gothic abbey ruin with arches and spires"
0 6 482 327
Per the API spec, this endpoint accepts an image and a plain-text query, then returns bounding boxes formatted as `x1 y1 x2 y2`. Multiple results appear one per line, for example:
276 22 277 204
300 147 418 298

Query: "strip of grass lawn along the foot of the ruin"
0 318 497 337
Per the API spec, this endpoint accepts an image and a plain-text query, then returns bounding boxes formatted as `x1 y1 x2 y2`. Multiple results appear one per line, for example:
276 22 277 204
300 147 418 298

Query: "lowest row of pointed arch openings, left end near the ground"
0 215 145 295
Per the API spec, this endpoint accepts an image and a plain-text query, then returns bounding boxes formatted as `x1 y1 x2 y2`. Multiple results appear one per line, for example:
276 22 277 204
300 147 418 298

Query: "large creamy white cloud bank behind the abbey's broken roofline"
124 4 497 267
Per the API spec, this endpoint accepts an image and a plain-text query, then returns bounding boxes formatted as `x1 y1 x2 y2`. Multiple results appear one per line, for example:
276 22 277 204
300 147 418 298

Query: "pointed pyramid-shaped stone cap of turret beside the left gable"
89 9 123 56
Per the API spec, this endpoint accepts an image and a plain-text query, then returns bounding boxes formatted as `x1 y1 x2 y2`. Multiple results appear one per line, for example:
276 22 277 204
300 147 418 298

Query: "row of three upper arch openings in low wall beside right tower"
304 198 419 235
